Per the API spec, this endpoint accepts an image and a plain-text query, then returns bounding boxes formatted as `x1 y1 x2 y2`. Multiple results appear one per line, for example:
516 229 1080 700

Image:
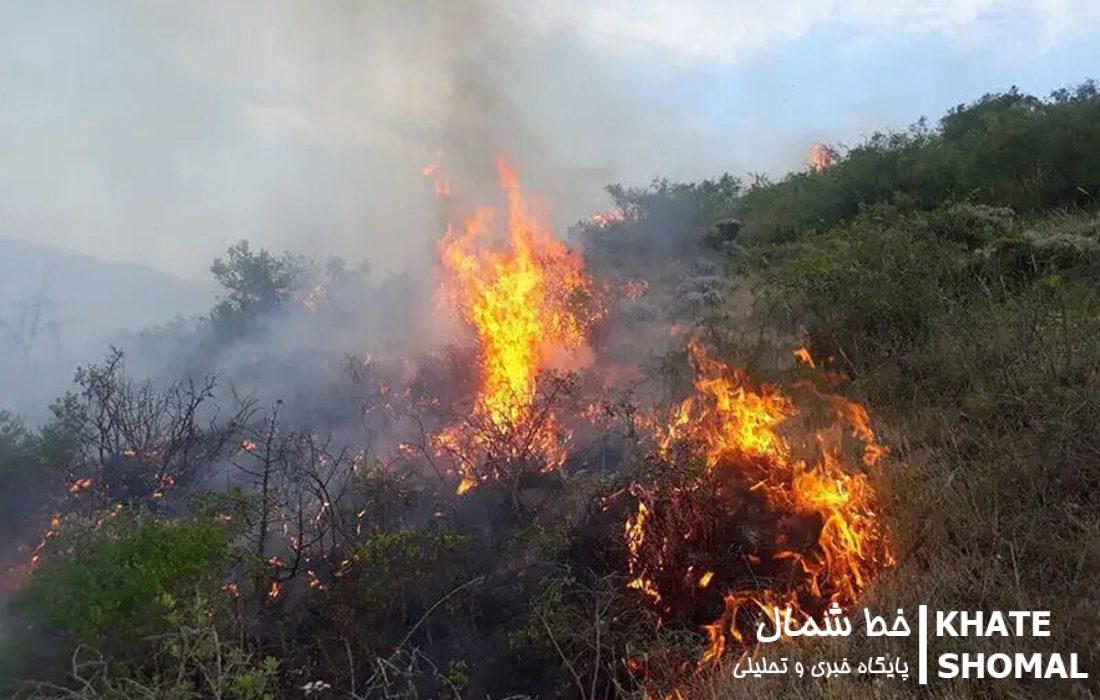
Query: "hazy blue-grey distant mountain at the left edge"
0 238 213 420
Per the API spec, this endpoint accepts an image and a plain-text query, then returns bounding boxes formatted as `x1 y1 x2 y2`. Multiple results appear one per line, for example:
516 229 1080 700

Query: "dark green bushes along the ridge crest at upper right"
737 81 1100 242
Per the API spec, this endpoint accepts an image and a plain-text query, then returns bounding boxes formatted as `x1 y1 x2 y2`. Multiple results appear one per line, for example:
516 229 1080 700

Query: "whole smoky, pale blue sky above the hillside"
0 0 1100 280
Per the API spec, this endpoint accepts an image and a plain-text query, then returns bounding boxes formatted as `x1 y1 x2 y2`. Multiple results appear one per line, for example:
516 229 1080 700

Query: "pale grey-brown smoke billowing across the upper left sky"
0 1 651 277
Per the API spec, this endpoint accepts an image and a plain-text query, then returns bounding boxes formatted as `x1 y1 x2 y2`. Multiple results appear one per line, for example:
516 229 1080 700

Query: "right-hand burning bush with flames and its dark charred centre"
625 341 894 663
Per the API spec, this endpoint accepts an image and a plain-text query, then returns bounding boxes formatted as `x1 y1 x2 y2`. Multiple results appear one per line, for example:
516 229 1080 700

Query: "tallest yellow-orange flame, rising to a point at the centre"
438 160 600 493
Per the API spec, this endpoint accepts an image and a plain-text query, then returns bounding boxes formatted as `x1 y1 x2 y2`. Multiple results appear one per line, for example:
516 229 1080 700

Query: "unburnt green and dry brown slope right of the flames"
700 84 1100 698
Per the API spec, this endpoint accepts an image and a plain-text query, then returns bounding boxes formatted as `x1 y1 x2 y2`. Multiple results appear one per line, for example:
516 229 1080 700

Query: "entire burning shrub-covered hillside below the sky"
0 83 1100 700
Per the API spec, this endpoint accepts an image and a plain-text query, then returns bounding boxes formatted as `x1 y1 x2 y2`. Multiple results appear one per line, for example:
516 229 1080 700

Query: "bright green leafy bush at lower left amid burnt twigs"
23 512 230 644
